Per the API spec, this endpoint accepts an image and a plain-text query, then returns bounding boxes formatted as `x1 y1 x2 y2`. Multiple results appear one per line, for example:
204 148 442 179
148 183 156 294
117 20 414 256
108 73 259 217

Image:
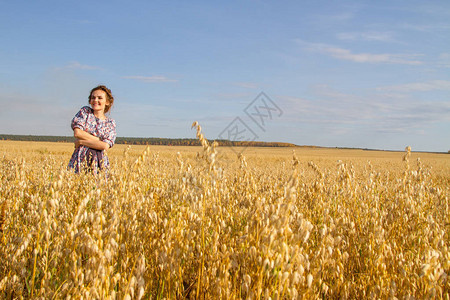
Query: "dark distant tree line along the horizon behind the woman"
0 134 296 147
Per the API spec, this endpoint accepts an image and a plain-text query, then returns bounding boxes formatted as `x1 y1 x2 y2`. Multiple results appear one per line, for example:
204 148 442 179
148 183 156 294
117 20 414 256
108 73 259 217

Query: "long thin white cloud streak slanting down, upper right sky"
296 39 423 65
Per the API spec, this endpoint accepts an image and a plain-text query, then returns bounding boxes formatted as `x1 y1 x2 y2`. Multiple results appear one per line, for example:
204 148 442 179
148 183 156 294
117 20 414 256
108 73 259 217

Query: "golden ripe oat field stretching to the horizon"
0 131 450 299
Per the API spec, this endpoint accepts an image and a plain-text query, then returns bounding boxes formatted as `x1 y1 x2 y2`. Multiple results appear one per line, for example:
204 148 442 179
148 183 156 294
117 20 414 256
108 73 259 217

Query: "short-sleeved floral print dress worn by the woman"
68 106 116 173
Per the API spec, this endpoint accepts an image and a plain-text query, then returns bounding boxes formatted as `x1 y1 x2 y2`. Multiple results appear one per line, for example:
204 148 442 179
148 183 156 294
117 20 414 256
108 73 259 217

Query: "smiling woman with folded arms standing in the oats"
68 85 116 173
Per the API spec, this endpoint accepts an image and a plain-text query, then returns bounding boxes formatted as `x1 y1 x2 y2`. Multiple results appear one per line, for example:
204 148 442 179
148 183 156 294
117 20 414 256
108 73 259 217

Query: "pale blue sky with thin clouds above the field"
0 0 450 152
